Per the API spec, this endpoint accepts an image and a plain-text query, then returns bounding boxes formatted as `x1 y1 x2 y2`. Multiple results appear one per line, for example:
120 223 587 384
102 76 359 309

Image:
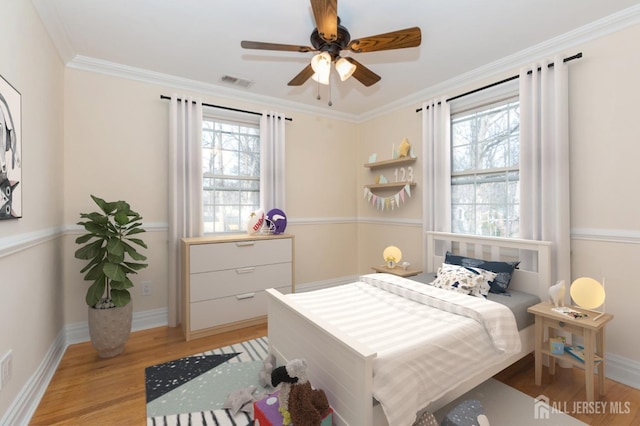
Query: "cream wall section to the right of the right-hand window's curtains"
570 25 640 362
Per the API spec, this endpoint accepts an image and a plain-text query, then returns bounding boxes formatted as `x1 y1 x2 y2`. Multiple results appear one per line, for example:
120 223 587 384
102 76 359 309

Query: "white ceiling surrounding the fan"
32 0 640 117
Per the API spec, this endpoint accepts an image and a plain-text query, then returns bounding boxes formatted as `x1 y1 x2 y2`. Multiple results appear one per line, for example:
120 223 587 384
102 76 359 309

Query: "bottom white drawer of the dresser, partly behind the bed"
190 286 291 331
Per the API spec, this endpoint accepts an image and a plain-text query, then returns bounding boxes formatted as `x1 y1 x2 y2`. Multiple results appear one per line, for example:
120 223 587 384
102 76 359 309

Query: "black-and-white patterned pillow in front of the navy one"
431 264 496 297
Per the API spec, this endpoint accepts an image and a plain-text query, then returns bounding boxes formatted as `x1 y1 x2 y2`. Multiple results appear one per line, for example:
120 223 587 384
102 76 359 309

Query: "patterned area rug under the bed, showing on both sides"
145 337 584 426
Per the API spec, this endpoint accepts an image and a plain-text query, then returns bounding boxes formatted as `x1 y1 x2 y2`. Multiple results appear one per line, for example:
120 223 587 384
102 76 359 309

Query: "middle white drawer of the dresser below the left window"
190 262 292 302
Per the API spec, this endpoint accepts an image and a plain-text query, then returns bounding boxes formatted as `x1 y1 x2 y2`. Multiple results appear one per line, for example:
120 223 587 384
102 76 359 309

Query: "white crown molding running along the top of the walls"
51 4 640 123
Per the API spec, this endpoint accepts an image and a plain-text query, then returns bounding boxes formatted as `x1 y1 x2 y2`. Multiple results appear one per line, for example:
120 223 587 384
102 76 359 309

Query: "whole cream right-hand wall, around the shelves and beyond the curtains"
356 25 640 368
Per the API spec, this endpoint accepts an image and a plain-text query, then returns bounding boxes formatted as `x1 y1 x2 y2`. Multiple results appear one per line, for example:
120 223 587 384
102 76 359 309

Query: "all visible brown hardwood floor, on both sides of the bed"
30 325 640 426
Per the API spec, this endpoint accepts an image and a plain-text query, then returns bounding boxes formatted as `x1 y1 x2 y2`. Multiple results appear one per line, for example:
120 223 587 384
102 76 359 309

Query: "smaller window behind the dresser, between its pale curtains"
202 116 260 233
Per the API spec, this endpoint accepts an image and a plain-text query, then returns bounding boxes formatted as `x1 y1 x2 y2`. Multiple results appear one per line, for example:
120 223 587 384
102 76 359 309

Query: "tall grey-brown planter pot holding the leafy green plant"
89 302 133 358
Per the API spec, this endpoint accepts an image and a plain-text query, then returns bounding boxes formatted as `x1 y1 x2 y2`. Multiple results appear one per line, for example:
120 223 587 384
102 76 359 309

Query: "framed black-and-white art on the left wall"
0 76 22 219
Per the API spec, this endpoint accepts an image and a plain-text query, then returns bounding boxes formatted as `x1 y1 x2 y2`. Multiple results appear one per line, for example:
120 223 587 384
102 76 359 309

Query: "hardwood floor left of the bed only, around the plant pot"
30 324 267 426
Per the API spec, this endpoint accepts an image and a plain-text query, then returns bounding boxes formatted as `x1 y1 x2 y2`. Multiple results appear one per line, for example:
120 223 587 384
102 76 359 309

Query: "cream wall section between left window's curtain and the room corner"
285 112 358 285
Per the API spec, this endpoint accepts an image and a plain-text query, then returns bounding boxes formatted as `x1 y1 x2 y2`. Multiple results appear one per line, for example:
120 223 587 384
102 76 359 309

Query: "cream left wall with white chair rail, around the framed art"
0 1 64 423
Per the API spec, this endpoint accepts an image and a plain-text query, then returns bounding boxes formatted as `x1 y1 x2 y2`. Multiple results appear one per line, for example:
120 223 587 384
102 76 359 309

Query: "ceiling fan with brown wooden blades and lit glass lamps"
240 0 422 87
